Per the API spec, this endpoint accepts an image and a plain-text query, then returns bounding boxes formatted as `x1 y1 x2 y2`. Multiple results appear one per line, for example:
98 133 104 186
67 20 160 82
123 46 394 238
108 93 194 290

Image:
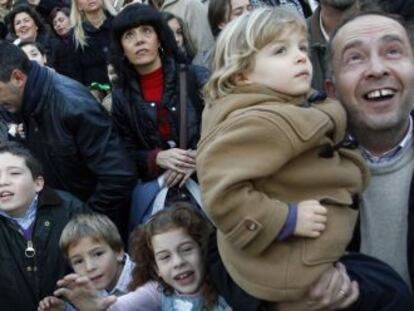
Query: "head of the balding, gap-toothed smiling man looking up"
327 15 414 133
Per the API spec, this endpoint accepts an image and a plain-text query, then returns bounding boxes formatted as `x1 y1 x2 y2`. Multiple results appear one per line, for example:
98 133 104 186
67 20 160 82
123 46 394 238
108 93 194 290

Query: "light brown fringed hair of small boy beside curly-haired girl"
59 213 124 257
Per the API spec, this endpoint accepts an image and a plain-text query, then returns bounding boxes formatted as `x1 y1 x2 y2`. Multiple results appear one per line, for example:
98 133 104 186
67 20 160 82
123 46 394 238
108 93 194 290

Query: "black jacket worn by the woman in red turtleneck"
112 59 209 180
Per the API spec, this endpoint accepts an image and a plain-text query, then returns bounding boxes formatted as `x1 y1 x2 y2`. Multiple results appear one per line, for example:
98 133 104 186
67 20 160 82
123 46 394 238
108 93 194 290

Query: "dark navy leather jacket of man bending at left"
12 63 137 226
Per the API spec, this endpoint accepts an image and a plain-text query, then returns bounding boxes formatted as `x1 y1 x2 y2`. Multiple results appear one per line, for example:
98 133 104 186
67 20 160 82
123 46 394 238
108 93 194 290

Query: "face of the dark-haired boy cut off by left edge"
0 152 44 217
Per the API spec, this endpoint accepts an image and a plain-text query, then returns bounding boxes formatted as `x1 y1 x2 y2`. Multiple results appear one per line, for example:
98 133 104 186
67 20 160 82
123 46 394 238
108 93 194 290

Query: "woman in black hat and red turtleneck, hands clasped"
111 4 208 222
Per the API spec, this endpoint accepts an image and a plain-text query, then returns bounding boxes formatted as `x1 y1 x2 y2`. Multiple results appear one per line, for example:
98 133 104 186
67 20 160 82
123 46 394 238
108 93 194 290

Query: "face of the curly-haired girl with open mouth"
151 228 204 294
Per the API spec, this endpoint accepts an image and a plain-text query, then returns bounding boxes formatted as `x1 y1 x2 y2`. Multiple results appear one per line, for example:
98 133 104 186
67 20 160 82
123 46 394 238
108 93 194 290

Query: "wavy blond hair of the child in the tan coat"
204 7 308 102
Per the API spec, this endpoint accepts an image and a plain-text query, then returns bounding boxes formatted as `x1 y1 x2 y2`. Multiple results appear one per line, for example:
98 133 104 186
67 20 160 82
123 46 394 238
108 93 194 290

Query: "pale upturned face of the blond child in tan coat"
245 30 312 96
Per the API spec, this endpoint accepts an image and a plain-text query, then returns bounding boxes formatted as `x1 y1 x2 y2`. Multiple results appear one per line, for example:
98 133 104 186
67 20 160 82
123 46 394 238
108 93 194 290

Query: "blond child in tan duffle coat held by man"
197 8 368 310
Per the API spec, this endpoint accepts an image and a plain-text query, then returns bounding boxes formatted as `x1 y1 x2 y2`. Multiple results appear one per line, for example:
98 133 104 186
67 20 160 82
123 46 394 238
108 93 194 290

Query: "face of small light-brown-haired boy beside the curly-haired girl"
68 237 124 291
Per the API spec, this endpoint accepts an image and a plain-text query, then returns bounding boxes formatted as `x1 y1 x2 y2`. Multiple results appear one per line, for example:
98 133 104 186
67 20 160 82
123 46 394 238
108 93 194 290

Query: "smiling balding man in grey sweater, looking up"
327 13 414 287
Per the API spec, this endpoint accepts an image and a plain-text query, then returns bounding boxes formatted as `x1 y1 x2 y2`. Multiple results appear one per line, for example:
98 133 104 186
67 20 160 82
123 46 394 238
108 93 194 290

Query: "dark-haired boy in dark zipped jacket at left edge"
0 143 85 311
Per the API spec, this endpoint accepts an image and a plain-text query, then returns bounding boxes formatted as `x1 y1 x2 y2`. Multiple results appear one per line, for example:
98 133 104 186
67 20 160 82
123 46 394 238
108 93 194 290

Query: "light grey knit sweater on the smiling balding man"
360 146 414 285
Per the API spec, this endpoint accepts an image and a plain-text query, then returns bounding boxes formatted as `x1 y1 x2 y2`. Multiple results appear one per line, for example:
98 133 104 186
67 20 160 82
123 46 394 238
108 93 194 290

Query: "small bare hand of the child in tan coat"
294 200 327 238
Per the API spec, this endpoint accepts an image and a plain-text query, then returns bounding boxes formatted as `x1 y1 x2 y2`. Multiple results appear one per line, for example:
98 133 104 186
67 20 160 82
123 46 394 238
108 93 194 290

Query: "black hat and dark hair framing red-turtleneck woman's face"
110 3 185 85
